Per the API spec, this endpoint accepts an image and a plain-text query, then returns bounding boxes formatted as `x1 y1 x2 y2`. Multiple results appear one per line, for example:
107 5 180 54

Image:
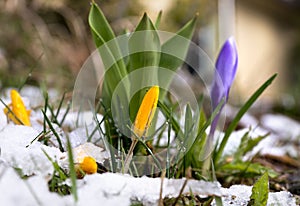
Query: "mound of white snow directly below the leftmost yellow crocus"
0 124 61 175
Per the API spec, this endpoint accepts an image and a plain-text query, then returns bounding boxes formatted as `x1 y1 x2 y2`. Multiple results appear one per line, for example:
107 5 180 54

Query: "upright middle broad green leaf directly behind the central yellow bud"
128 13 160 120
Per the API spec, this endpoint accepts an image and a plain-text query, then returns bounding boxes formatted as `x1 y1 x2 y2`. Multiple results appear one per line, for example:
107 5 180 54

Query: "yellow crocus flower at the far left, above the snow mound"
3 89 31 126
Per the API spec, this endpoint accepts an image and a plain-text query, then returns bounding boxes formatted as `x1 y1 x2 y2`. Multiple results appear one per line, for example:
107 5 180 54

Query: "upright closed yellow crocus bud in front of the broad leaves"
133 86 159 137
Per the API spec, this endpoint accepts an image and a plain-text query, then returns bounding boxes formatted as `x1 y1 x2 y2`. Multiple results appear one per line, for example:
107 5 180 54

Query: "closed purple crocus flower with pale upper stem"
210 37 238 136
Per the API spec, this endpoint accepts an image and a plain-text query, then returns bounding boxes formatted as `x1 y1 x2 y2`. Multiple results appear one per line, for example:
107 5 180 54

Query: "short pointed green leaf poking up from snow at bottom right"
248 172 269 206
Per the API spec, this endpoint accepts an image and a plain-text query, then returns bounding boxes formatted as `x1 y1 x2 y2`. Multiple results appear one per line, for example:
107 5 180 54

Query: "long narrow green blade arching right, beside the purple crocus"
214 74 277 166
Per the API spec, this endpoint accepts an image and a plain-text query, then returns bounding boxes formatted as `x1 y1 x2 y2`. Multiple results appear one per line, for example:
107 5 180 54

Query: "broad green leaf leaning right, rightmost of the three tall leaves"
158 17 197 98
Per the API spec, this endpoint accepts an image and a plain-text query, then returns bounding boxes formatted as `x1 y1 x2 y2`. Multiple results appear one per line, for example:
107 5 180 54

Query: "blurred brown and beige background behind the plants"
0 0 300 118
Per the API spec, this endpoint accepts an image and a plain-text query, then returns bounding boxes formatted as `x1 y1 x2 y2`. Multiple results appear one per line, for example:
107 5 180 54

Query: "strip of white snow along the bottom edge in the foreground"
0 163 296 206
